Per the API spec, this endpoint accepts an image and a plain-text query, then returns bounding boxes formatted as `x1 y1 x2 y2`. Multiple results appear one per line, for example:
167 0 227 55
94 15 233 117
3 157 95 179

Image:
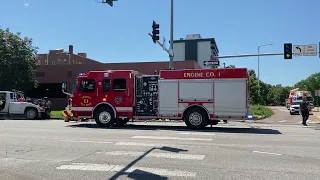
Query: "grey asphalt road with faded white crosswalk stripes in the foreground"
0 120 320 180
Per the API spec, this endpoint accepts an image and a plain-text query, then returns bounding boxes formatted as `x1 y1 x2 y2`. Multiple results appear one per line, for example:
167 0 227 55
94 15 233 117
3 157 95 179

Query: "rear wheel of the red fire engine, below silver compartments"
184 108 209 129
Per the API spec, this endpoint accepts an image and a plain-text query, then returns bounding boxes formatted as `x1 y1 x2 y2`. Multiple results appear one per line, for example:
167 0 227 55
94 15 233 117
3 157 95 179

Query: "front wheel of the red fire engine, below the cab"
94 107 115 127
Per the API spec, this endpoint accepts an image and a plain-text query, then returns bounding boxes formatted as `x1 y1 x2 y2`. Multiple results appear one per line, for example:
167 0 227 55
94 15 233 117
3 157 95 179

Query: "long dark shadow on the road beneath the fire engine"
67 123 282 134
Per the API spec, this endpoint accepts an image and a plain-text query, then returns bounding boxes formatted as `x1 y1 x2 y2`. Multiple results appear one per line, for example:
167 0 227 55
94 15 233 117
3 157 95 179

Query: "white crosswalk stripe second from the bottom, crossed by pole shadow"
96 151 205 160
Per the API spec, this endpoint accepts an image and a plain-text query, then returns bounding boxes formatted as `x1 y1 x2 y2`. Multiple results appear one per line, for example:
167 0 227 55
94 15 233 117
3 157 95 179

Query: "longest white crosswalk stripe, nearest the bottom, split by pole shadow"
57 163 197 177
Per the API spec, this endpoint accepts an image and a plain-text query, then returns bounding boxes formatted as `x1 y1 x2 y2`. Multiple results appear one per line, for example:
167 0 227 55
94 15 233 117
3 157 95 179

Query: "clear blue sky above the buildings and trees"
0 0 320 85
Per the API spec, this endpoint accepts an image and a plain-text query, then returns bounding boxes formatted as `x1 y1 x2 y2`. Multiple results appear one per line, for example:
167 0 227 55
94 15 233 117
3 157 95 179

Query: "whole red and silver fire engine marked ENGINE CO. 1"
62 68 252 129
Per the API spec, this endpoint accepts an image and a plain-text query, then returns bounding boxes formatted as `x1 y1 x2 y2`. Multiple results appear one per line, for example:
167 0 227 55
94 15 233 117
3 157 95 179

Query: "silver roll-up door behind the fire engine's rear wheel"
214 79 247 118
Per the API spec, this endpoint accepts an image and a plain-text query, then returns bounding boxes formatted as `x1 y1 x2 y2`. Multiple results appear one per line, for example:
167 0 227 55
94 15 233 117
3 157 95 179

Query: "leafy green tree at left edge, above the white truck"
0 28 37 91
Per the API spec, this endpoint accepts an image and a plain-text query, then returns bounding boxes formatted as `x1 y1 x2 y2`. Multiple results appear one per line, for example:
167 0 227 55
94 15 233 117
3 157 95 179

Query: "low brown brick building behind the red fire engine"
32 45 200 109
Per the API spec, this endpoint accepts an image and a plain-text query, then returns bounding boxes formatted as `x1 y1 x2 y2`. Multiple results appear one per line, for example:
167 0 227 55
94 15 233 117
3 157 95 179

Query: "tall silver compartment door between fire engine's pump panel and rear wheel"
158 80 178 116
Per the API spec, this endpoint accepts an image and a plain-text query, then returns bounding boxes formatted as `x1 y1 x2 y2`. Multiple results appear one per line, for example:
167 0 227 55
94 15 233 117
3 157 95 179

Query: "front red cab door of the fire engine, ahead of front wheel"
72 78 97 116
